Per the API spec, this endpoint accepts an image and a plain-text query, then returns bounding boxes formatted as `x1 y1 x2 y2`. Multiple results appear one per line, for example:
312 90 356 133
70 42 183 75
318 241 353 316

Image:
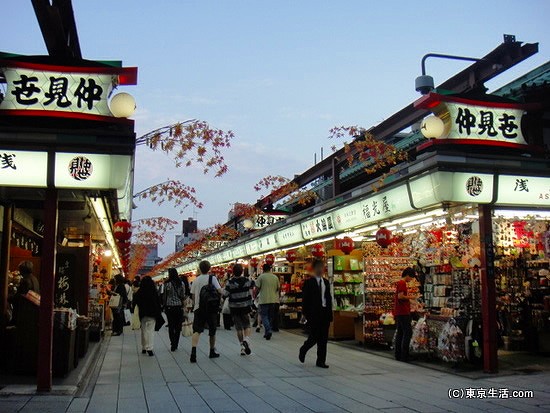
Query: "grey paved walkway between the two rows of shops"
0 328 550 413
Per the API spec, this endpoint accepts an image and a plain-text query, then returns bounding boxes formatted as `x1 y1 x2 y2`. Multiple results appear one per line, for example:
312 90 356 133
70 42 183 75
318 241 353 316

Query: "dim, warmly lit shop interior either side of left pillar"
0 188 121 377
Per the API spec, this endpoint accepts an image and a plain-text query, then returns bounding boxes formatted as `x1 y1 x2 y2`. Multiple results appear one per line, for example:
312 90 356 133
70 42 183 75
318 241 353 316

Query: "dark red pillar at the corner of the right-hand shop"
479 205 498 373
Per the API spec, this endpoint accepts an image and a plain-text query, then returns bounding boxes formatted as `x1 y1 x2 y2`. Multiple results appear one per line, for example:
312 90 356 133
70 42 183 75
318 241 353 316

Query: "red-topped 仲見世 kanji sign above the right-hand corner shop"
415 93 527 145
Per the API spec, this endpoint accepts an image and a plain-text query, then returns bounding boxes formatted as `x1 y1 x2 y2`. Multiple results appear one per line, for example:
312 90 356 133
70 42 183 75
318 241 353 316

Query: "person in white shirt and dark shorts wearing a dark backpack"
190 260 222 363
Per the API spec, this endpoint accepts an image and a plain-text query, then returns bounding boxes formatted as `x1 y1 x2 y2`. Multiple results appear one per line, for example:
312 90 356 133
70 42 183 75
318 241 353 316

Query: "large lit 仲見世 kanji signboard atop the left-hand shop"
0 67 117 116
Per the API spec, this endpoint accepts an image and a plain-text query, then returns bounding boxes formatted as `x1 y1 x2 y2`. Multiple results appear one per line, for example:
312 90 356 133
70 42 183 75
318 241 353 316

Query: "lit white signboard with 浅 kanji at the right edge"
497 175 550 207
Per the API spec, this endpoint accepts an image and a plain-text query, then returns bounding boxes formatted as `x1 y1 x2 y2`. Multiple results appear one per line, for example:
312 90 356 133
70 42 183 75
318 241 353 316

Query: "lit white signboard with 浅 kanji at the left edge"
0 149 48 188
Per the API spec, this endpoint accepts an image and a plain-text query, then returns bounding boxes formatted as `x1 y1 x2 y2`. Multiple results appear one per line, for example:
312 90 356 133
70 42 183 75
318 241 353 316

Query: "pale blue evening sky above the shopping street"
4 0 550 255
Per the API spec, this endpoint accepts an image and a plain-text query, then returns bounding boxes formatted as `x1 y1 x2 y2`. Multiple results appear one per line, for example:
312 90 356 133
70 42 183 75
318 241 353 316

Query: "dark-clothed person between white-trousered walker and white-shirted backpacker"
162 268 185 351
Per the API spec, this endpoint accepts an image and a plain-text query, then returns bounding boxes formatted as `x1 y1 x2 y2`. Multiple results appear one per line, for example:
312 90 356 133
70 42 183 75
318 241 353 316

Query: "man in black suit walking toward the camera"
299 260 332 369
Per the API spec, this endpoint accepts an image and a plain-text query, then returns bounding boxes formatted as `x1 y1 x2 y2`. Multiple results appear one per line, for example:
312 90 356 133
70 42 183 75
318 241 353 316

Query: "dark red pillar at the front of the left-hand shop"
37 188 58 392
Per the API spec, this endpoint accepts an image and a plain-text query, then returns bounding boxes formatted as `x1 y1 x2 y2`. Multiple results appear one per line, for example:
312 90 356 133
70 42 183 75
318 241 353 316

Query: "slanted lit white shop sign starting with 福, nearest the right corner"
333 185 413 231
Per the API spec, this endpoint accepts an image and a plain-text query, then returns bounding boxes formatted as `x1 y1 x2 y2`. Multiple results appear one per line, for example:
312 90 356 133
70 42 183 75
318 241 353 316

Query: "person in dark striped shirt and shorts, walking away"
224 264 254 356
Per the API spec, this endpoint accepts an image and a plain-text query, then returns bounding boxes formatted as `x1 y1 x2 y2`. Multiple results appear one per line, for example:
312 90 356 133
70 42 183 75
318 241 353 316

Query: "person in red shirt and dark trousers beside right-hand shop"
393 267 417 362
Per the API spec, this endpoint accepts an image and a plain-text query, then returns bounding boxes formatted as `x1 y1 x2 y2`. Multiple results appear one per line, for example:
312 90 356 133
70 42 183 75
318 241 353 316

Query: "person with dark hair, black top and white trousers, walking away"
134 276 162 357
